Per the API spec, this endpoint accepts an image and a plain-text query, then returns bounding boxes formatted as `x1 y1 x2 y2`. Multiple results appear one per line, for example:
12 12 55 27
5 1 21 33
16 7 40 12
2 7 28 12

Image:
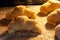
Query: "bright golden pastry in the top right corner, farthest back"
39 0 60 15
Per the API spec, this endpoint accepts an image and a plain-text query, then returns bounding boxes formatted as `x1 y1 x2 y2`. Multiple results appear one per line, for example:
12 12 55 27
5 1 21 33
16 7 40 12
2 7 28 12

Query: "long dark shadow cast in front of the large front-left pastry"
0 30 40 40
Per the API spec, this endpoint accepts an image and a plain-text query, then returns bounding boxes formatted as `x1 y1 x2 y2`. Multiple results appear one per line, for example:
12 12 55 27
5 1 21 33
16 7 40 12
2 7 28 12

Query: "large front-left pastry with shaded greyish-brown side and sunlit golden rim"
8 16 41 34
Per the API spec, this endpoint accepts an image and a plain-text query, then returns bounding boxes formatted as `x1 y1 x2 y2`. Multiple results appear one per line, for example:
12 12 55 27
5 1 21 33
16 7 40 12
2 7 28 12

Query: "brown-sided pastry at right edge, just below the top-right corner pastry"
47 9 60 25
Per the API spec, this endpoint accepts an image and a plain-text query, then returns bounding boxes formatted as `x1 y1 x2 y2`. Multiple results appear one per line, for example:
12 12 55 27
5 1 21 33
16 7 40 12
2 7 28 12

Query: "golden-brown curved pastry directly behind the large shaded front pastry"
5 5 36 20
